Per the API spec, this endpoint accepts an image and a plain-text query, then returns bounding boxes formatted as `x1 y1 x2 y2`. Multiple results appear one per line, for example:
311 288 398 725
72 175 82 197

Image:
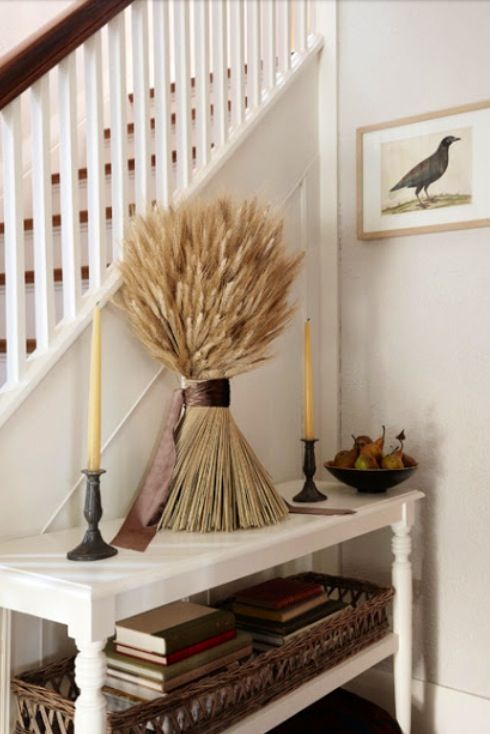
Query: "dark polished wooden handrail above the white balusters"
0 0 133 109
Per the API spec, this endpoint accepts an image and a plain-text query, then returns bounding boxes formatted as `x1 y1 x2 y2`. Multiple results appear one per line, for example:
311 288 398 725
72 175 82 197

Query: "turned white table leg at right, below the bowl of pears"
392 520 412 734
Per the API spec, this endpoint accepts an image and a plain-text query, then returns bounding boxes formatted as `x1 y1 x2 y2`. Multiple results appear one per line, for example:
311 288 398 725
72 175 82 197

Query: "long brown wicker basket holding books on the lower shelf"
12 573 394 734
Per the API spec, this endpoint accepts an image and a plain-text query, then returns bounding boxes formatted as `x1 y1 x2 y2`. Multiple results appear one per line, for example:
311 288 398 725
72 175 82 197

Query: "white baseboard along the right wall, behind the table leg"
345 668 490 734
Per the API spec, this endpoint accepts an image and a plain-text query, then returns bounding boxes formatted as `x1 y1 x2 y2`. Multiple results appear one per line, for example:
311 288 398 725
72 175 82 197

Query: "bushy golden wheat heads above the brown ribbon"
119 197 302 380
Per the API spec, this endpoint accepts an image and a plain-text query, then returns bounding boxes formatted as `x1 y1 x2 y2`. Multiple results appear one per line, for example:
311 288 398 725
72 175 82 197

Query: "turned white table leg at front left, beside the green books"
75 639 106 734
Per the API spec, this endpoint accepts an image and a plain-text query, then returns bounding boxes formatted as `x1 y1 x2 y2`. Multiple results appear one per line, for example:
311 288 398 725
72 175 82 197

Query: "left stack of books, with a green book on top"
106 602 252 699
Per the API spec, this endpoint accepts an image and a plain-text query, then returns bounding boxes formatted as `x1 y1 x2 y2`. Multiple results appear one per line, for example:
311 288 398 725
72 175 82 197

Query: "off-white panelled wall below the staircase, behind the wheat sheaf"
0 53 336 688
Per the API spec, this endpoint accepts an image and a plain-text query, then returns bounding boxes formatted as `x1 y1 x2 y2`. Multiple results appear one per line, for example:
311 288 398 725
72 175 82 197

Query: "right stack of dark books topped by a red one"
231 577 349 650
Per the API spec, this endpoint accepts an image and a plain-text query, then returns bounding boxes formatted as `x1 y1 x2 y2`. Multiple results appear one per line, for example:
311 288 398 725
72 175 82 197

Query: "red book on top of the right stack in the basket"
235 577 325 609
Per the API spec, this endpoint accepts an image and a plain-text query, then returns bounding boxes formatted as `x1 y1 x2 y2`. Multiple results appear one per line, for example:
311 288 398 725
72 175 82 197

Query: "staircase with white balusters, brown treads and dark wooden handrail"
0 0 321 424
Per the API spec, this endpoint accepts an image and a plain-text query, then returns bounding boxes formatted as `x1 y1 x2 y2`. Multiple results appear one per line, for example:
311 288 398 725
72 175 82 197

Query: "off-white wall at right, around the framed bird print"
338 0 490 734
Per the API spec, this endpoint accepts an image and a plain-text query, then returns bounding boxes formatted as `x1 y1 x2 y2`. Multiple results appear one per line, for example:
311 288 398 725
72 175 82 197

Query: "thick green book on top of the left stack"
116 601 235 655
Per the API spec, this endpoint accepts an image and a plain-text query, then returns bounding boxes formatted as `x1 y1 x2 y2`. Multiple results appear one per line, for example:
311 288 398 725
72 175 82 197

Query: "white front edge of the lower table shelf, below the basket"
226 633 398 734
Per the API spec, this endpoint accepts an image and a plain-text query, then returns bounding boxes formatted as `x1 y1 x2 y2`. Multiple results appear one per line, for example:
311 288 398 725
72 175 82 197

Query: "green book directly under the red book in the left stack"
106 632 252 682
